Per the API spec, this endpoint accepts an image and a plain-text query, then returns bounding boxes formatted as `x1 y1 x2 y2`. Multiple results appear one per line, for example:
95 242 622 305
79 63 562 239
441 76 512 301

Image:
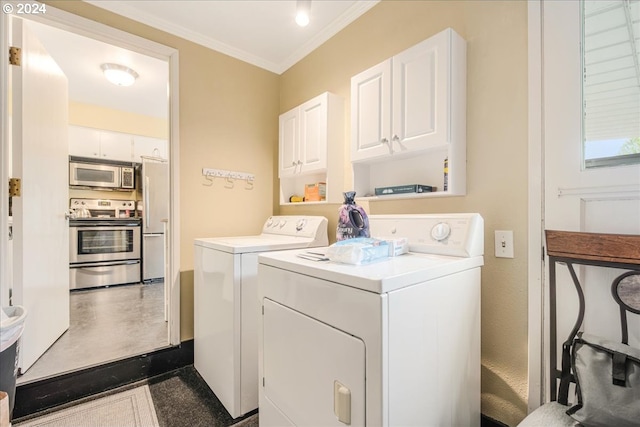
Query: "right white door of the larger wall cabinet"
391 31 451 154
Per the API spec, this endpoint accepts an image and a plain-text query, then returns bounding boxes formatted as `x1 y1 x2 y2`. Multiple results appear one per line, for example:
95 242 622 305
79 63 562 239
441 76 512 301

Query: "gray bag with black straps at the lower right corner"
567 333 640 427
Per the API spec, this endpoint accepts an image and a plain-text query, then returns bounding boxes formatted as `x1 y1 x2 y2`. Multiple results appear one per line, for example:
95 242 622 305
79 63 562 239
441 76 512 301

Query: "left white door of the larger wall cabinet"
351 60 391 161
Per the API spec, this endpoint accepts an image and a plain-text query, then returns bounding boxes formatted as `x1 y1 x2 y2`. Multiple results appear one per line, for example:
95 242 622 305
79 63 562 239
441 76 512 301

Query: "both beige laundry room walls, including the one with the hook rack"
47 0 527 425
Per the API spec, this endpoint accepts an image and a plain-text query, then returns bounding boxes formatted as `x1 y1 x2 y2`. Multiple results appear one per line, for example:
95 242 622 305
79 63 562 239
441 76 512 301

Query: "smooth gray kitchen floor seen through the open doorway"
17 282 169 385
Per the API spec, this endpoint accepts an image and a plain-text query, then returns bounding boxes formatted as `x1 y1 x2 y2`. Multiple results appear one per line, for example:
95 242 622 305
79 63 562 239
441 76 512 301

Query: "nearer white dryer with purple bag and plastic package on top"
258 214 484 427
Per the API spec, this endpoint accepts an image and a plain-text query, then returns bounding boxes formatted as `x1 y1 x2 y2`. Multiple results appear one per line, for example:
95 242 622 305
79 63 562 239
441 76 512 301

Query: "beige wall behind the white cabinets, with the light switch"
274 0 528 425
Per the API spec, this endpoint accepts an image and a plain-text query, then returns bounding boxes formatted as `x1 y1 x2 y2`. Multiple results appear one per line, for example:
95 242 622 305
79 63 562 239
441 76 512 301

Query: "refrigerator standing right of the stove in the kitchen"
141 159 169 283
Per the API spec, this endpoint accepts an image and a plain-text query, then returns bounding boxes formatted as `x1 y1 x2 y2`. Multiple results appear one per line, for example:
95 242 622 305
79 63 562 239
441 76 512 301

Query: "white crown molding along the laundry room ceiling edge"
85 0 380 74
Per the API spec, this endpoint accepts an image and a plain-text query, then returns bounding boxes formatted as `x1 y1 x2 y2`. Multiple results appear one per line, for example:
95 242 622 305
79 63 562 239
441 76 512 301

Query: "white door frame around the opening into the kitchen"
0 1 180 345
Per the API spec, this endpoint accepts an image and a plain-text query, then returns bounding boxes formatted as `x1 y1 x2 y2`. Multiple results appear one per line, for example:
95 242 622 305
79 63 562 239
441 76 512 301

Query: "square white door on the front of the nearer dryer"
260 298 366 427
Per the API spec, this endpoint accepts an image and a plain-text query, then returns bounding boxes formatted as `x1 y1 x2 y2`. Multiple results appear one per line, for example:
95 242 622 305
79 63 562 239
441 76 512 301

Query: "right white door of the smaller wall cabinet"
298 94 328 173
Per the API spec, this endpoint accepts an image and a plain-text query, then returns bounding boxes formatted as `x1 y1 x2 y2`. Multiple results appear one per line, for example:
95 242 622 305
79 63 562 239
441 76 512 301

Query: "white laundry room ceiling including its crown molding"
85 0 379 74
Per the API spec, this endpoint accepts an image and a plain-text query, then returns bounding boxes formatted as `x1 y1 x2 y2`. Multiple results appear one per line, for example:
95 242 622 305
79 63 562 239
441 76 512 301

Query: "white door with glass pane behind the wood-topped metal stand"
542 1 640 398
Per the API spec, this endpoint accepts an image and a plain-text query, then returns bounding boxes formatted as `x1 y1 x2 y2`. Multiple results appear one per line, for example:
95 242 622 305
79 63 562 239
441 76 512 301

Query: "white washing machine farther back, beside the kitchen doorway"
194 216 328 418
